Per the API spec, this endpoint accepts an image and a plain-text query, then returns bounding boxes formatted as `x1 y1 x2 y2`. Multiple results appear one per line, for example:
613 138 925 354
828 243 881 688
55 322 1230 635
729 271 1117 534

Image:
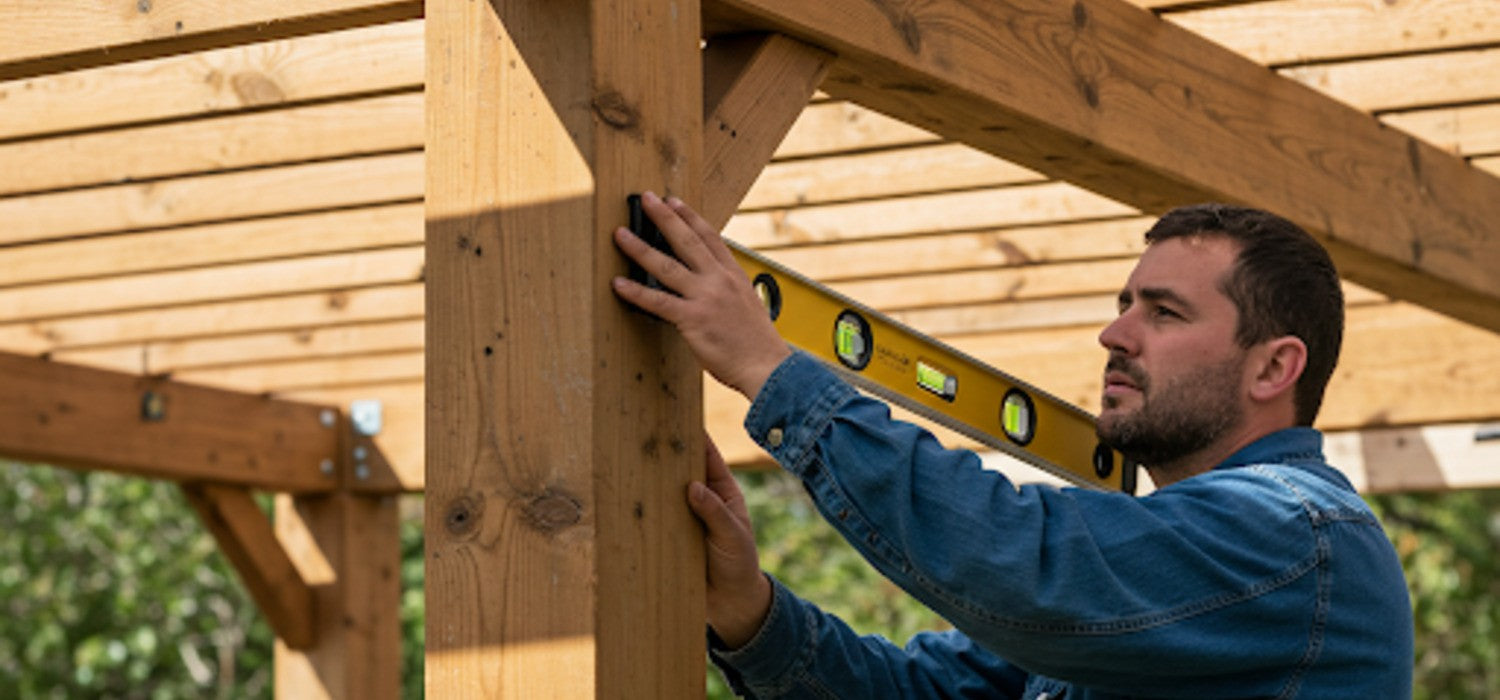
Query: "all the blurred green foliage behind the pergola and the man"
0 460 1500 700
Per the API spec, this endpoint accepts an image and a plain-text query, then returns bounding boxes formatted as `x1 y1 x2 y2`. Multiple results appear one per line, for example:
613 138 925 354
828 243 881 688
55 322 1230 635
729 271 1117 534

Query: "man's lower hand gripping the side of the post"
687 439 771 649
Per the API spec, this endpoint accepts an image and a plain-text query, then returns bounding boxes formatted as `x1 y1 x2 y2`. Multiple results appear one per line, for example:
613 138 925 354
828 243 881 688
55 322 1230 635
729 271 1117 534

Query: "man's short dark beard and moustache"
1095 355 1244 466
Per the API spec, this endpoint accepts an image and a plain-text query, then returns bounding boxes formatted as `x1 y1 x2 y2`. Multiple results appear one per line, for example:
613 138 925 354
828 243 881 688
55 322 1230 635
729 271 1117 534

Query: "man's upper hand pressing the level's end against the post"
614 192 792 400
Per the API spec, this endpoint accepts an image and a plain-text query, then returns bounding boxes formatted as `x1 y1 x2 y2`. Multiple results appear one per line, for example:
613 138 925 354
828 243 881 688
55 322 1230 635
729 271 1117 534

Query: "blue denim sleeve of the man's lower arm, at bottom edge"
708 579 1026 700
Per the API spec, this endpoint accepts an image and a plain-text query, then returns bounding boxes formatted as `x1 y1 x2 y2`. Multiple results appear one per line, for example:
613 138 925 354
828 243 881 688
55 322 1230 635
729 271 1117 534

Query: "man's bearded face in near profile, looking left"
1098 237 1245 466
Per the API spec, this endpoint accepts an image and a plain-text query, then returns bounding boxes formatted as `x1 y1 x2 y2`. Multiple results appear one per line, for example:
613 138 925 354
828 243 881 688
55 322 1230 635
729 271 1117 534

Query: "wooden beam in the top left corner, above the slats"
0 0 422 79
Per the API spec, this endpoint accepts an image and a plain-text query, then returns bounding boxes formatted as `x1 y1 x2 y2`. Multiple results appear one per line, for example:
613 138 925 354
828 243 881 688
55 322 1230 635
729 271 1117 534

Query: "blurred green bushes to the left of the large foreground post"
0 460 423 700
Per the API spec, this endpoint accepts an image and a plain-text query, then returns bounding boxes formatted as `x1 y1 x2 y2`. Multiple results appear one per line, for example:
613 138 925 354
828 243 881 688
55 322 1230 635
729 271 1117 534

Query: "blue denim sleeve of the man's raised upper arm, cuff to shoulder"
746 352 1319 694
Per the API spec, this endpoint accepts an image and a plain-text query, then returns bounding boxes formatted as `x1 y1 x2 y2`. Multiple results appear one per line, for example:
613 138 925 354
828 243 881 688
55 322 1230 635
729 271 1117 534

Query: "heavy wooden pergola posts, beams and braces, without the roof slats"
0 0 1500 699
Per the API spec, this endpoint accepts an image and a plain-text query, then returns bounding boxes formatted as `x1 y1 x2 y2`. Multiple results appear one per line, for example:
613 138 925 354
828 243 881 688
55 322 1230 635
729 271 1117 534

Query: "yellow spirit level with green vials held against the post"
725 240 1137 493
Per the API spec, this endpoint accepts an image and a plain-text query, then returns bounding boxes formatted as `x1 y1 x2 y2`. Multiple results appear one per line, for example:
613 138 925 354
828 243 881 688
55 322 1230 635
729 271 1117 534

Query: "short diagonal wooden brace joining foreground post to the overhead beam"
701 34 834 226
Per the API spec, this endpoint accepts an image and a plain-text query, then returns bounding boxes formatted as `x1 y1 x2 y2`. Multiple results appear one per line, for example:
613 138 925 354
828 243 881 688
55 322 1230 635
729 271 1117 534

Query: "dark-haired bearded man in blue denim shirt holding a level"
615 190 1412 699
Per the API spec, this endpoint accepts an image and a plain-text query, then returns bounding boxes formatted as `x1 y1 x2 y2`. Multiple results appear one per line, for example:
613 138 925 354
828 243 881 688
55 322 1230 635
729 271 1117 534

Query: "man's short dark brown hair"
1146 204 1344 426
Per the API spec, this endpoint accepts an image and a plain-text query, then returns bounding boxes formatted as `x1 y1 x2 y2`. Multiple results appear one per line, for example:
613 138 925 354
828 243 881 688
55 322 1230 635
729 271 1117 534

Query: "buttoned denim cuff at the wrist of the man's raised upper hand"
744 351 860 475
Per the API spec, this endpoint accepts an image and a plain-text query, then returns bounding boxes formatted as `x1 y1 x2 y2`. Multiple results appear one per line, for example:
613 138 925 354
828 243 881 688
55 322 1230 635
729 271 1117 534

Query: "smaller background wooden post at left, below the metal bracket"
275 492 402 700
